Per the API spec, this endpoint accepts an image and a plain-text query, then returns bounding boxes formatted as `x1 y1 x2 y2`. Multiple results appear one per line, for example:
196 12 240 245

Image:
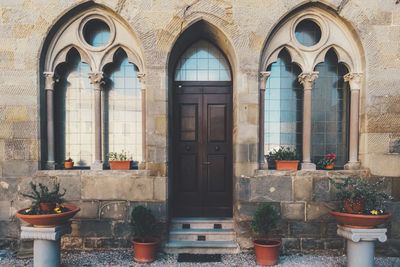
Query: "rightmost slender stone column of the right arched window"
343 73 362 170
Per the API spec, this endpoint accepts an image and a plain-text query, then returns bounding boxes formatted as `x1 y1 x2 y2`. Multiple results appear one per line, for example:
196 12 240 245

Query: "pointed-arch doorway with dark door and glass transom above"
170 40 232 217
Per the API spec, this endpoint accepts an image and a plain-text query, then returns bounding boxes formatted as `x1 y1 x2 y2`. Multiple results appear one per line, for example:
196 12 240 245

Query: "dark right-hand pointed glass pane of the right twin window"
311 49 349 167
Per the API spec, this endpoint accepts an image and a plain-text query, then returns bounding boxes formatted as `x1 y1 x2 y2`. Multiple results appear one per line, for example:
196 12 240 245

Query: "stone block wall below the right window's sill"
234 170 400 255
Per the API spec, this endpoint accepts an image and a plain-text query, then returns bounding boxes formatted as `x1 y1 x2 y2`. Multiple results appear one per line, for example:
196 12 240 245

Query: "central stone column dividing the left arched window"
89 72 104 170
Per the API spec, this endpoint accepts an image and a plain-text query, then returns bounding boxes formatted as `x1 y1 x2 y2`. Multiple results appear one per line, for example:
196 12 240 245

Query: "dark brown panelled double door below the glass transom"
172 82 232 217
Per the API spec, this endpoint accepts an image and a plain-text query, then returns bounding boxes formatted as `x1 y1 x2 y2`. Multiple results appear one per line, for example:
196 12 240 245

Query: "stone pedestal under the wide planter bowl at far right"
337 225 387 267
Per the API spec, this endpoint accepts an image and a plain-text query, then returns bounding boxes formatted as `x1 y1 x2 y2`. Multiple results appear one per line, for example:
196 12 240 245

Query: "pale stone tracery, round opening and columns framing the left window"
42 5 146 169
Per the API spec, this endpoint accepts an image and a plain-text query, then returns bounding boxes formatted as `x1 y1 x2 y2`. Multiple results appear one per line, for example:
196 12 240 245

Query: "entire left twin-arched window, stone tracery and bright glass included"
41 5 146 170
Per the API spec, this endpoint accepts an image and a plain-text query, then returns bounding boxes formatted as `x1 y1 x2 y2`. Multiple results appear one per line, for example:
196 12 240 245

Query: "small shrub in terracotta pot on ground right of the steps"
251 204 282 266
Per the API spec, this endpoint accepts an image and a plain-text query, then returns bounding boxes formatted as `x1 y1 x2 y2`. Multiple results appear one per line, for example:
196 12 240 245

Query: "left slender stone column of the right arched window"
258 71 271 170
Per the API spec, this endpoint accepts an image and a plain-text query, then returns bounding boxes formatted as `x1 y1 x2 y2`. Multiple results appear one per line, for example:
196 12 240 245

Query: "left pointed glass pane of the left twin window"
55 49 94 167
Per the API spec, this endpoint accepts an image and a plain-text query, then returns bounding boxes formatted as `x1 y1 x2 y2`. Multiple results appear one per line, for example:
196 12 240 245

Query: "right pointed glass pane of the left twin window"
103 49 142 161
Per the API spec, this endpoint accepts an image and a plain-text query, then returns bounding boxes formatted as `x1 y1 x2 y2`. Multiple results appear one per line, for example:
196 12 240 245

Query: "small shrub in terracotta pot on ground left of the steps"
131 206 160 263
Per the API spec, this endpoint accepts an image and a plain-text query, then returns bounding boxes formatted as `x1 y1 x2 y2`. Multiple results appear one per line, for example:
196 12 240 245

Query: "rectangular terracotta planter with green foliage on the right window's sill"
268 146 299 170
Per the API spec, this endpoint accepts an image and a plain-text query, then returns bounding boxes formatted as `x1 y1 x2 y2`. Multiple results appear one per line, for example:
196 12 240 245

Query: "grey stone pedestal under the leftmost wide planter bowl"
21 224 71 267
